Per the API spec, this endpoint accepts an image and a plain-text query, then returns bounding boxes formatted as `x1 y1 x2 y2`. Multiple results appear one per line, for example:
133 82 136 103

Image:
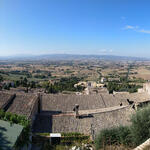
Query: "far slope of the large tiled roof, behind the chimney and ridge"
42 93 150 111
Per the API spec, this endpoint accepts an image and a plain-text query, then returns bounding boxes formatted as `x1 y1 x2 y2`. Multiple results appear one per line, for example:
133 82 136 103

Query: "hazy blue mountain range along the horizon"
0 54 150 61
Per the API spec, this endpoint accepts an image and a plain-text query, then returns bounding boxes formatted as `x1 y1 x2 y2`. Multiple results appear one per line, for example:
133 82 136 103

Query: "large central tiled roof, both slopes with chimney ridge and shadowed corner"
34 93 139 137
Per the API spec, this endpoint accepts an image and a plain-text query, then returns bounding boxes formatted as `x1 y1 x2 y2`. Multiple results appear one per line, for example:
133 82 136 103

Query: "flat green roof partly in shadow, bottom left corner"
0 120 23 150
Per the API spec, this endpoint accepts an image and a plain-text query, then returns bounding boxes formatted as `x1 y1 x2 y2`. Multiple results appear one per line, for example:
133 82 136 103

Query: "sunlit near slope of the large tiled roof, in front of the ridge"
52 106 134 138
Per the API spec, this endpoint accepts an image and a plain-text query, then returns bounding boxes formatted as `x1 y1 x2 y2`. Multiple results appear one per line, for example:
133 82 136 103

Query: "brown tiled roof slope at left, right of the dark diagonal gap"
7 94 38 118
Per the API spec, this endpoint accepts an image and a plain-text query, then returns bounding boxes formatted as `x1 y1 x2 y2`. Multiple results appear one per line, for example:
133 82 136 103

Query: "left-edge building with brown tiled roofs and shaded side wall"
0 92 40 124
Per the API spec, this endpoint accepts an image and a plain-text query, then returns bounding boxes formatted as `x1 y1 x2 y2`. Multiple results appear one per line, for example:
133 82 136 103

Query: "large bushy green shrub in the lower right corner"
95 105 150 149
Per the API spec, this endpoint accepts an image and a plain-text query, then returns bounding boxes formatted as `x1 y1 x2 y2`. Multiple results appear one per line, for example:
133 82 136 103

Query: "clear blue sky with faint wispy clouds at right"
0 0 150 57
